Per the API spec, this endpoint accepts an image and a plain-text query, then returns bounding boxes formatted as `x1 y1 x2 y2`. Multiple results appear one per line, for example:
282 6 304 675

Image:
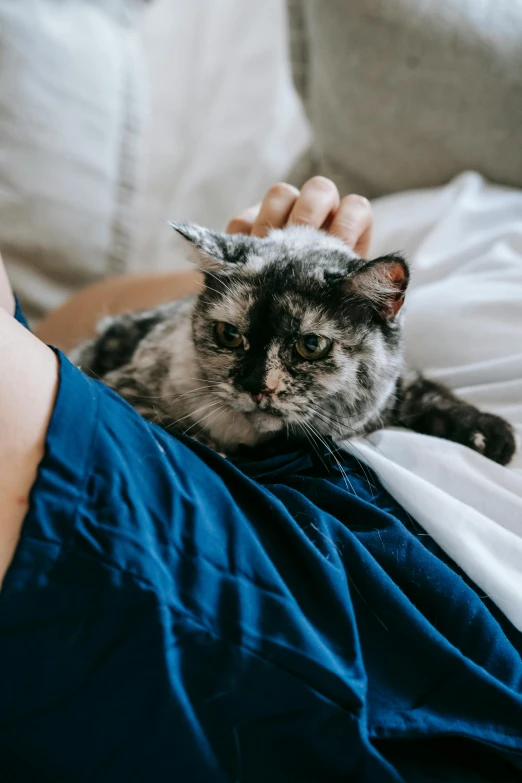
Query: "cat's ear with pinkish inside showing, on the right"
345 253 410 320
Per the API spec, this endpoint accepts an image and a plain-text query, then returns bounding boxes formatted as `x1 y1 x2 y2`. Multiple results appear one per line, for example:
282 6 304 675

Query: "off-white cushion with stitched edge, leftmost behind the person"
0 0 141 318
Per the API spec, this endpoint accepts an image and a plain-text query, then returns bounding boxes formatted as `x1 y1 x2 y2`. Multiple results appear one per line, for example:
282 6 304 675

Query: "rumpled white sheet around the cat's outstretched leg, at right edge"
346 173 522 630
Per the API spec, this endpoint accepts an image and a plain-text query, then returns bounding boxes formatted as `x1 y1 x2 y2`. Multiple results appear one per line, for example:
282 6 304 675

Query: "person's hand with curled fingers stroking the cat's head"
227 177 373 258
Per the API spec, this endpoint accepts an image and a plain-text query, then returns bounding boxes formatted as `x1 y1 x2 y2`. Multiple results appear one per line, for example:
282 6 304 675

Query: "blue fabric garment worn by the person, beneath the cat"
0 304 522 783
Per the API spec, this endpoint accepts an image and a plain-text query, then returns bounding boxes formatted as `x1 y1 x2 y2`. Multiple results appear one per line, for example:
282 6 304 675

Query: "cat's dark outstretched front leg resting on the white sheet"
393 376 516 465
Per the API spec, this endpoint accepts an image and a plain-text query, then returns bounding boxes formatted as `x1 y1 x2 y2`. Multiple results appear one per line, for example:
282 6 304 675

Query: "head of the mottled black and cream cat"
173 224 409 448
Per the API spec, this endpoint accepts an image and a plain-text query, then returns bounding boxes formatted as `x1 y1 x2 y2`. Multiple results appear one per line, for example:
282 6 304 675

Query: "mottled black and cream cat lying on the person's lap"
72 223 515 464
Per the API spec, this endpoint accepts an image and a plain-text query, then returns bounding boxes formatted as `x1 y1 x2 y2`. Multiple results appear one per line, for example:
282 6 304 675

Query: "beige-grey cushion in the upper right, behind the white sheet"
289 0 522 197
